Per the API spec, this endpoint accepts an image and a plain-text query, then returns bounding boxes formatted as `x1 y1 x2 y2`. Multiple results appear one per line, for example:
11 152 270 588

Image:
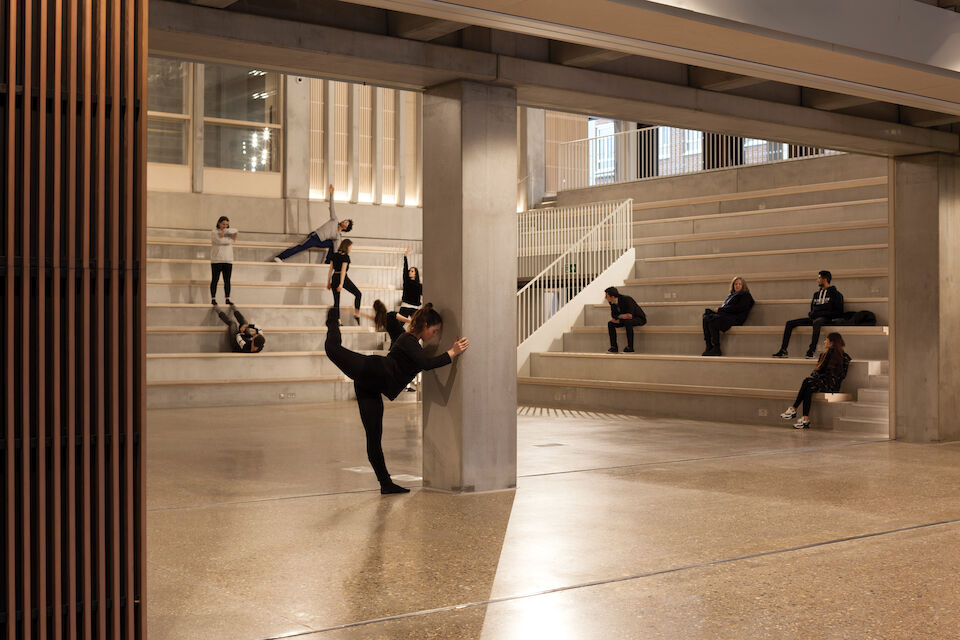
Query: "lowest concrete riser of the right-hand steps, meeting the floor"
517 383 872 435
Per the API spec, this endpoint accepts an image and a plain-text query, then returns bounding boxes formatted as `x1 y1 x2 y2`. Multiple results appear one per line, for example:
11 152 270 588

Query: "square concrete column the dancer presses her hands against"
423 81 517 491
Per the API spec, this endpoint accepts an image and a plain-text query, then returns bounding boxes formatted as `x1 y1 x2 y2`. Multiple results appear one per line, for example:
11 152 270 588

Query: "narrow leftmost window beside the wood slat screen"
147 57 191 165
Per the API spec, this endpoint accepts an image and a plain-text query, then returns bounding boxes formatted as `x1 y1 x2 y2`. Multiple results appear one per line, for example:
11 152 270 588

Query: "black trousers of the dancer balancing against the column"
324 324 391 485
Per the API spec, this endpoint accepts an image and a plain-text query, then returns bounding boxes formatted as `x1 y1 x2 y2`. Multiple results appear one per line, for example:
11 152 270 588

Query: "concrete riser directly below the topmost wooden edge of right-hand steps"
632 185 887 222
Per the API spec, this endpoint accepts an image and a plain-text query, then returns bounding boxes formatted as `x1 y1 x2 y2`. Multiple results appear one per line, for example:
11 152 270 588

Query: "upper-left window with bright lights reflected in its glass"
203 64 283 172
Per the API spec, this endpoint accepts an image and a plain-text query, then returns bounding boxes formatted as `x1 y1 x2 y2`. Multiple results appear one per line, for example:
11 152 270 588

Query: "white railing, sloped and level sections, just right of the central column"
517 200 633 344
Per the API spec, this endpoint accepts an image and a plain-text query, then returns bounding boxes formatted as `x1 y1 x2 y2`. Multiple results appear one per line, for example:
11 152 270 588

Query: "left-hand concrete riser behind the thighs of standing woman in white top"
147 261 402 286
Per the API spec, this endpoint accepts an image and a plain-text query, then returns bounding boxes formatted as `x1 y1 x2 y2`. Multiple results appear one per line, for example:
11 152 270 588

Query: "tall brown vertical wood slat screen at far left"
0 0 147 640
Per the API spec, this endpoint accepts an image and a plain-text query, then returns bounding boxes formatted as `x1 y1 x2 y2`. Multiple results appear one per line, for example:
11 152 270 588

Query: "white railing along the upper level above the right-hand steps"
557 127 841 191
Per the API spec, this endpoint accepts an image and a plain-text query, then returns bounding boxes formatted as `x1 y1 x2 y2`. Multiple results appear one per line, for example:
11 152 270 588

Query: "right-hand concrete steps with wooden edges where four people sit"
519 155 889 436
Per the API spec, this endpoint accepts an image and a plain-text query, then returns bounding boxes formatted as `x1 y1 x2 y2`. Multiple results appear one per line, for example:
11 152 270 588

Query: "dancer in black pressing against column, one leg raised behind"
324 303 470 494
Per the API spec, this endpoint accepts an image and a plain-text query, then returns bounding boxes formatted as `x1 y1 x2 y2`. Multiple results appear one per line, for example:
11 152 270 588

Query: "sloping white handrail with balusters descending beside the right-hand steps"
517 198 633 345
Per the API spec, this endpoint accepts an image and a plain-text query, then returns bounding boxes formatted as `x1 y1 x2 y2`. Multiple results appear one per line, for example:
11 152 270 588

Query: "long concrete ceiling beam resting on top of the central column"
149 0 960 155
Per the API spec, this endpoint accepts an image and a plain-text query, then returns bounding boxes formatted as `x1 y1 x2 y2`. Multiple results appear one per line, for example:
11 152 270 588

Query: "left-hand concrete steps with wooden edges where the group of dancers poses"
146 229 419 408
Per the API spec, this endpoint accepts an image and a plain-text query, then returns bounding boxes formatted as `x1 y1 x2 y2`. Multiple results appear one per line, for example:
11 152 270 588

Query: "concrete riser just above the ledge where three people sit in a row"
584 294 887 331
